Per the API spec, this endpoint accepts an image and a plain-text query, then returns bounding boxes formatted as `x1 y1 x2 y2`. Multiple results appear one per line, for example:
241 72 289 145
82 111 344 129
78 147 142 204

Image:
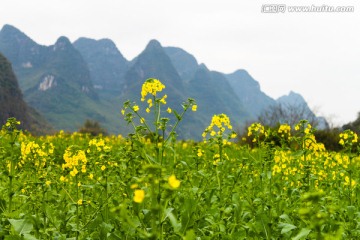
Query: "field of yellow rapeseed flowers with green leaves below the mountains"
0 79 360 240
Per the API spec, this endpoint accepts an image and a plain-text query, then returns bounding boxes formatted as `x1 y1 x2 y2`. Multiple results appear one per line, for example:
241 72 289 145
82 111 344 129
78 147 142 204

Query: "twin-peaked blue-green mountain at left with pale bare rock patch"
0 25 117 131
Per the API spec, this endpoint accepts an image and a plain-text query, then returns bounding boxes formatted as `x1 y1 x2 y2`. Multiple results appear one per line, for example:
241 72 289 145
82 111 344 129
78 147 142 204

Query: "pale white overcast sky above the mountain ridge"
0 0 360 124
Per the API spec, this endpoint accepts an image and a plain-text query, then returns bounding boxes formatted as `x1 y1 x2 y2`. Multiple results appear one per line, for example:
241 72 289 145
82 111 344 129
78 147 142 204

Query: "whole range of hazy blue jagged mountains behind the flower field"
0 25 324 139
